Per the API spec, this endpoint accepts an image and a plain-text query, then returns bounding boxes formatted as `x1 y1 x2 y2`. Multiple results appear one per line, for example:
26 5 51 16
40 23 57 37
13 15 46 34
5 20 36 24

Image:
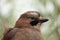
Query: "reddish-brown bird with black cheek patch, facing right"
2 11 48 40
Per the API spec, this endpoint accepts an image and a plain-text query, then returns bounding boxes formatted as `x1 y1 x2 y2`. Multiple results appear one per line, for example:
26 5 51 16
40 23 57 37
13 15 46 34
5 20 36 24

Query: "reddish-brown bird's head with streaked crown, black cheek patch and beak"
15 11 48 28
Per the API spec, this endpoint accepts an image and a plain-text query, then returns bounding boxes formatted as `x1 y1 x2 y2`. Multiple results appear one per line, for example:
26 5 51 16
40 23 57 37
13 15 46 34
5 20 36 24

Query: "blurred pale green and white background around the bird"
0 0 60 40
